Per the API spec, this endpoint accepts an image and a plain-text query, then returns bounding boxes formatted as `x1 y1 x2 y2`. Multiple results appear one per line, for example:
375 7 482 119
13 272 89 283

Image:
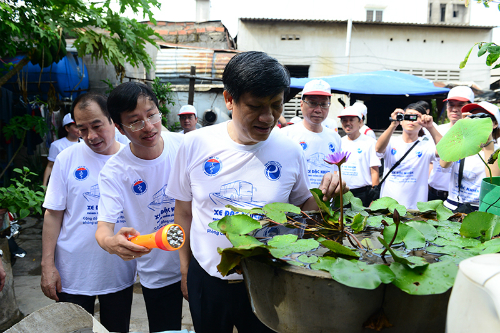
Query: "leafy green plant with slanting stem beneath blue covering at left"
0 114 48 178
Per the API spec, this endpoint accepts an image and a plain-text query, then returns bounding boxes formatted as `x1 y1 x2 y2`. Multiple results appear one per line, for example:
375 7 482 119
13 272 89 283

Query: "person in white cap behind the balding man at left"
42 113 80 186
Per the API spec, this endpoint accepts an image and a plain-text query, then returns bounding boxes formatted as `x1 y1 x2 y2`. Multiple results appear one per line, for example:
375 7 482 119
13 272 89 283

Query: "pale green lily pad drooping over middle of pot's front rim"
330 258 395 290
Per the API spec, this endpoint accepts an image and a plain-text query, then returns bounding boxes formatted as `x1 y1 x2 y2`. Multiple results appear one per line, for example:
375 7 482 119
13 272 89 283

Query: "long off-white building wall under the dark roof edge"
238 20 491 88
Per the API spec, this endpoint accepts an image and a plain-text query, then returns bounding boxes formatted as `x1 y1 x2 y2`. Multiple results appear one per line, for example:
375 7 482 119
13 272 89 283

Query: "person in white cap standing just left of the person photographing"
338 103 380 207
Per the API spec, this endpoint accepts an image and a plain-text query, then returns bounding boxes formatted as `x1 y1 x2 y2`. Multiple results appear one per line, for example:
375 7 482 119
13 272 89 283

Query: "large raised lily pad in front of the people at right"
436 118 493 162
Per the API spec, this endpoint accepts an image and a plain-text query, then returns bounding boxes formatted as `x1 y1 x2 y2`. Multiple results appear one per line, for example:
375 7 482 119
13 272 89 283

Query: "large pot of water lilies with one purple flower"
210 151 500 333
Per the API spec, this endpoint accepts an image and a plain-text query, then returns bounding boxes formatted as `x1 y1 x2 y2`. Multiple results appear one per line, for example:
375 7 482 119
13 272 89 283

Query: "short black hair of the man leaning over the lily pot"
222 51 290 103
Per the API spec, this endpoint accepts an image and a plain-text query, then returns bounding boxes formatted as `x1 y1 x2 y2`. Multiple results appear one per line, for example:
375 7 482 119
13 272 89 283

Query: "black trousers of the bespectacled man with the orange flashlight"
142 282 183 332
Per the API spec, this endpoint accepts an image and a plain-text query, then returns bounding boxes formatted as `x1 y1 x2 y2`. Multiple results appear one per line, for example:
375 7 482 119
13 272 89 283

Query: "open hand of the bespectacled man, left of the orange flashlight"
96 221 151 261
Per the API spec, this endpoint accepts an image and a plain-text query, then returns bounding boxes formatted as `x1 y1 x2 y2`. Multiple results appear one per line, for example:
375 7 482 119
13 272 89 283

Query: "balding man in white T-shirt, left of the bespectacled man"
40 93 137 332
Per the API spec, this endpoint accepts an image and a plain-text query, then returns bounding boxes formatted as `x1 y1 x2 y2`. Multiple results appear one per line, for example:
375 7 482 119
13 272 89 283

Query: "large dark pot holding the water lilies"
242 257 451 333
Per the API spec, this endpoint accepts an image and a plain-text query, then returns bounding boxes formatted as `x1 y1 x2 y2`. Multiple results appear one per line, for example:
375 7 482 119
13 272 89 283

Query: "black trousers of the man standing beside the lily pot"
187 257 274 333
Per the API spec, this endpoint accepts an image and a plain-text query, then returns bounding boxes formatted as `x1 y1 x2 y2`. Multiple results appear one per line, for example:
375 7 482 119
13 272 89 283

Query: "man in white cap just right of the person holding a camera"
428 86 474 201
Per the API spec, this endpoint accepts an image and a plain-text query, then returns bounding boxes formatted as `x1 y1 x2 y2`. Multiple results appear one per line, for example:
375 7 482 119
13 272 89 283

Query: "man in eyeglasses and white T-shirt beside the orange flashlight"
96 82 183 332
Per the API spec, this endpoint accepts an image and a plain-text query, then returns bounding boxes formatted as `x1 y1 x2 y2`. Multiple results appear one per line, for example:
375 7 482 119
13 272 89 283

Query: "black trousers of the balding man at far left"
57 286 134 332
